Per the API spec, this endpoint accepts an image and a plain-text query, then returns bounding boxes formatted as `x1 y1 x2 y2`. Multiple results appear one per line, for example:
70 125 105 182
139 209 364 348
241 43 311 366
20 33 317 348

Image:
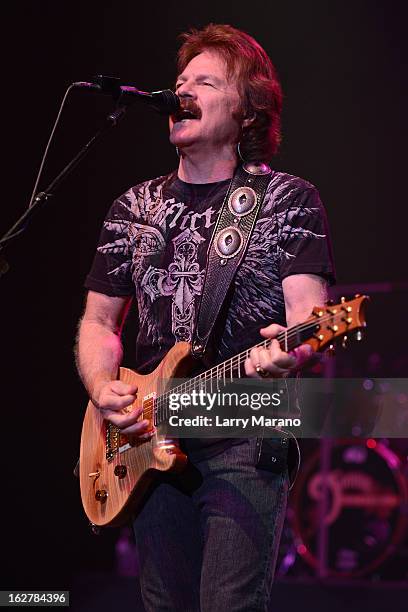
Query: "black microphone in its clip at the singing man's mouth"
72 75 180 115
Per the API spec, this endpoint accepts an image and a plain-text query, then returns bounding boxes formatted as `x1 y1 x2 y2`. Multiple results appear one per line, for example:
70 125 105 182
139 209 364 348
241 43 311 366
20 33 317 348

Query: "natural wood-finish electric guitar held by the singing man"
80 295 369 527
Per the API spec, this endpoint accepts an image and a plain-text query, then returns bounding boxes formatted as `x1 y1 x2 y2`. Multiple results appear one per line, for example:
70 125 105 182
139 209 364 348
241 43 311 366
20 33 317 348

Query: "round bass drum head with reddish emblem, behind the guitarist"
291 439 408 576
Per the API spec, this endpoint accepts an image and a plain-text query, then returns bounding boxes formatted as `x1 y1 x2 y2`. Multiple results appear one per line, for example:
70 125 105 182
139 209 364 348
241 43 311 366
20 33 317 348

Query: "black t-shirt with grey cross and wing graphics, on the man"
85 172 334 456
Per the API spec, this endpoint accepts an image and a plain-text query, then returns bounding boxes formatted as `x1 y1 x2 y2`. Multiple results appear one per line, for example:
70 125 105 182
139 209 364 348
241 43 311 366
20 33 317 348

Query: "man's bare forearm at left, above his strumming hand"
76 320 123 402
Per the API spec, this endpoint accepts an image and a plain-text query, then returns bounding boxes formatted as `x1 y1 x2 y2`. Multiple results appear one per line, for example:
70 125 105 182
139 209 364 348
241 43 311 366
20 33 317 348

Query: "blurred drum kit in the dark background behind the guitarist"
277 285 408 581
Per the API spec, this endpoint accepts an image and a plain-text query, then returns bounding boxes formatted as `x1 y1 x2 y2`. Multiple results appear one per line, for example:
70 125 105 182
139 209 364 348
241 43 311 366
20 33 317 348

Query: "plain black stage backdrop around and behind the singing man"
0 0 408 608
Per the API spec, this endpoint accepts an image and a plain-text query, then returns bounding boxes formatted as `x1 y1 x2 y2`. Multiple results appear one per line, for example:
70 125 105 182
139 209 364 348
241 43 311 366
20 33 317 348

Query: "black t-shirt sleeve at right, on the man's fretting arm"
278 186 336 285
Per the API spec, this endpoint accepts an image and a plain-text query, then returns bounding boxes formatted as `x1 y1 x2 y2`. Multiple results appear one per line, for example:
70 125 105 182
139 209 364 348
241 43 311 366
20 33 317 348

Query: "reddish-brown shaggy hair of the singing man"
177 23 282 161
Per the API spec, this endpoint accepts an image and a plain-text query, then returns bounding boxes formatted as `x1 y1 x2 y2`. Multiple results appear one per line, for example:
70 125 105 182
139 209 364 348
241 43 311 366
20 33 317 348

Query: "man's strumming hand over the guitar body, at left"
92 380 154 440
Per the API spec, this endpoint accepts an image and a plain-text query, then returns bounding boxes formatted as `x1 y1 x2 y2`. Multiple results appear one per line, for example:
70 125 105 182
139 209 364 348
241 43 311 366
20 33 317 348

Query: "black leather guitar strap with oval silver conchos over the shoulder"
191 162 272 358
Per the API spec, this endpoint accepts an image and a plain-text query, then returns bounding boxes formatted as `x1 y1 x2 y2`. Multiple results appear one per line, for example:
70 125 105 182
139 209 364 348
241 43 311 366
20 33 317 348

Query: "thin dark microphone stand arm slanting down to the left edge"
0 105 128 277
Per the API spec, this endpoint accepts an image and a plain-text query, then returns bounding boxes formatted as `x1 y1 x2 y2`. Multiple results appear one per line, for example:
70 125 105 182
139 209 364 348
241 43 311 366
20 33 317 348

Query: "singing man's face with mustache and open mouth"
170 51 240 151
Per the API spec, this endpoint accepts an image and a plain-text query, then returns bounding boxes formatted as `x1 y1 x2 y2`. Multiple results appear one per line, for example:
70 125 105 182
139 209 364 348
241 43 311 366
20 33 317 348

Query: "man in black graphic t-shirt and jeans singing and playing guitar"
77 24 334 612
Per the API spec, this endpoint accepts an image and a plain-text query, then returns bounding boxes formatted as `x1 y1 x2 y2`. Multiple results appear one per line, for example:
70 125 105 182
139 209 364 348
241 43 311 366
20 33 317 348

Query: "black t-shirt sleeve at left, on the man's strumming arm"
85 198 134 296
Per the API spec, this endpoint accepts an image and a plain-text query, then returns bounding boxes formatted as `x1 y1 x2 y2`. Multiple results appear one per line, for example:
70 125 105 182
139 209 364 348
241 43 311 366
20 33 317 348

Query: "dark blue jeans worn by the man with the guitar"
134 439 288 612
